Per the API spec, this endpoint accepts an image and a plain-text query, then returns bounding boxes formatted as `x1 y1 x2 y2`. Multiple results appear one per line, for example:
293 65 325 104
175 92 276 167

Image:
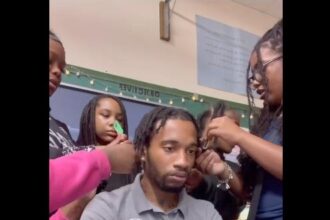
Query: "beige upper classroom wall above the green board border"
50 0 278 107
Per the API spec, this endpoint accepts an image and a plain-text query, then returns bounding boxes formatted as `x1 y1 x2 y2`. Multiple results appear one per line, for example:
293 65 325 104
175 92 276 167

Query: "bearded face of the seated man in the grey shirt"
144 119 197 193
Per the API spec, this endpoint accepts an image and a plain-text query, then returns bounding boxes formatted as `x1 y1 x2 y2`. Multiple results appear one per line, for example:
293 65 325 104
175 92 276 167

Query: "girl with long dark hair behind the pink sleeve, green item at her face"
77 95 134 193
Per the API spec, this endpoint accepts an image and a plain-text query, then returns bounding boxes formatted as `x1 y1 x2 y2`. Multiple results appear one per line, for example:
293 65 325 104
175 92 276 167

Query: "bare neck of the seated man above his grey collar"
141 175 179 212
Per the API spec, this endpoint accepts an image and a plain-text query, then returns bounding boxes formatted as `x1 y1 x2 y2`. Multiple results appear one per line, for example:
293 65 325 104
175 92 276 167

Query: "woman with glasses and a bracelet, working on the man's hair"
196 21 283 220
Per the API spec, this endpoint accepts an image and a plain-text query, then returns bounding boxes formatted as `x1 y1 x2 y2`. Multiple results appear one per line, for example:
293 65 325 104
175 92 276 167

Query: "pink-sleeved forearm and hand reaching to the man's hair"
49 143 135 220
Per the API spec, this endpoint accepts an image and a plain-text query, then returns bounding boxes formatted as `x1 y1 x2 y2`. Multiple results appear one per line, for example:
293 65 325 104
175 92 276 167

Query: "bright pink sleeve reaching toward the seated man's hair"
49 149 111 212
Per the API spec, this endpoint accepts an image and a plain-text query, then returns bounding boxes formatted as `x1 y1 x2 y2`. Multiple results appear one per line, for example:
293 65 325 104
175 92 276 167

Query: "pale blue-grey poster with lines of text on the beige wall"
196 15 259 95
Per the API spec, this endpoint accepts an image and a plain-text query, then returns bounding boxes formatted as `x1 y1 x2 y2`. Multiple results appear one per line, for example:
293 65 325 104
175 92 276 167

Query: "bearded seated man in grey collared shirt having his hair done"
81 107 222 220
